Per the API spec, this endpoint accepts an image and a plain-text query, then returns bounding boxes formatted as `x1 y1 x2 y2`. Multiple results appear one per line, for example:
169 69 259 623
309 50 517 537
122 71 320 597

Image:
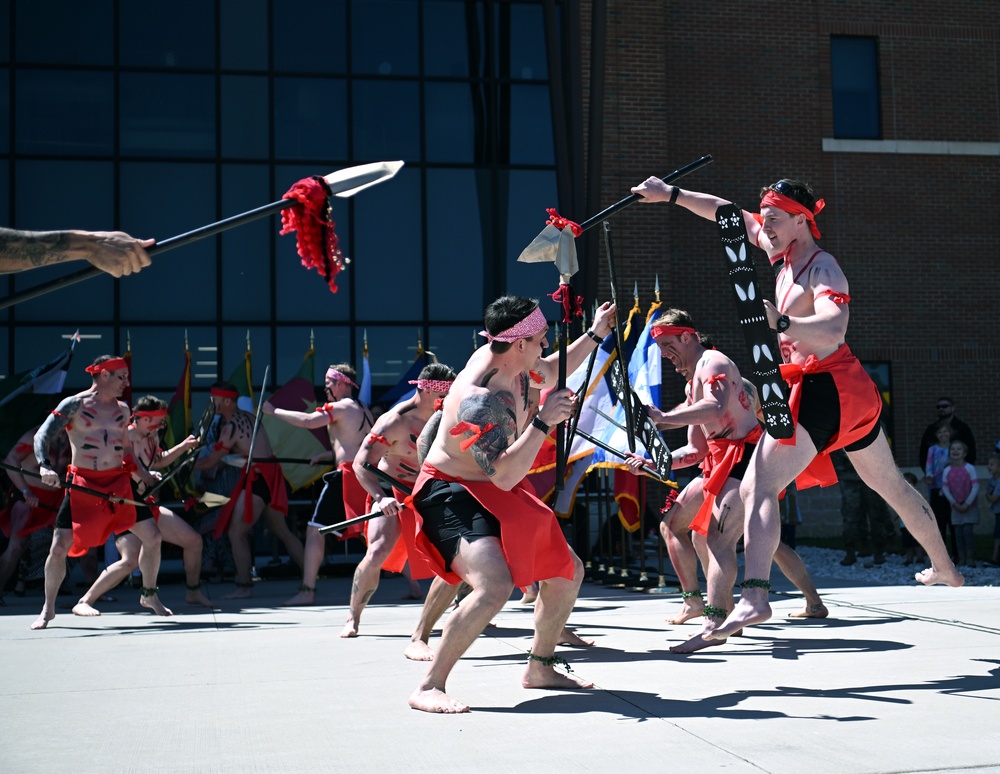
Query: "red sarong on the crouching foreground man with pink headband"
400 463 573 587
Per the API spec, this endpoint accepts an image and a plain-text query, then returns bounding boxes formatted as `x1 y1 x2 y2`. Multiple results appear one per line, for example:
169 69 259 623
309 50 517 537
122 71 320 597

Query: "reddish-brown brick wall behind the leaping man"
582 0 1000 484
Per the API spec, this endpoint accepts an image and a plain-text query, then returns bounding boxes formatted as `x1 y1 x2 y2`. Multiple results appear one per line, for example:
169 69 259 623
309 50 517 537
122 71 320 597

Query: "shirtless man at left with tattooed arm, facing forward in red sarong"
31 355 172 629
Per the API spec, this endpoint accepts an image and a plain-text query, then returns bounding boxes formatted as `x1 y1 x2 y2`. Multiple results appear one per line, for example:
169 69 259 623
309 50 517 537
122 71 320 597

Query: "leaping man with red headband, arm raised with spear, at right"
632 177 964 638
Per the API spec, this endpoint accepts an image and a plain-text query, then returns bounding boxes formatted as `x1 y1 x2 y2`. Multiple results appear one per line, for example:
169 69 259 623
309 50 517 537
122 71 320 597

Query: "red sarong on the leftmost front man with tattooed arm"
69 465 135 556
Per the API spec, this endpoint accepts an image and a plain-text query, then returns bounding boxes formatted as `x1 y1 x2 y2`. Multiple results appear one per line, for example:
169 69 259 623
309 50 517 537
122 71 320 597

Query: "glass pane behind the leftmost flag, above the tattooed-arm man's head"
14 325 114 394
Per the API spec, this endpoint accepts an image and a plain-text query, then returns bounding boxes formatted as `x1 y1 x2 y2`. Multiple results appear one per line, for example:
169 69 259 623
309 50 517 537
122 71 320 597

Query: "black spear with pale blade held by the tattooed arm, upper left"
0 161 403 309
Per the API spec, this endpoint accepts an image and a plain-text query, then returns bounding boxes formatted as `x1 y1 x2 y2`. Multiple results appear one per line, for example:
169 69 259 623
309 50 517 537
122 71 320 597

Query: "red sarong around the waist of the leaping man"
778 344 882 489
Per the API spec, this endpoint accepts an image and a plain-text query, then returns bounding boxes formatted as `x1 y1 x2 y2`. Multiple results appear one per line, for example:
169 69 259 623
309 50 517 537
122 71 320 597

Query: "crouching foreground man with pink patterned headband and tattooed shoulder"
402 296 614 713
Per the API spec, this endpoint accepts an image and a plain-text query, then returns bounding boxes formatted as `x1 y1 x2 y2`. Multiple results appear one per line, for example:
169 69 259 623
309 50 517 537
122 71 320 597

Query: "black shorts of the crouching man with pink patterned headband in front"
415 479 500 572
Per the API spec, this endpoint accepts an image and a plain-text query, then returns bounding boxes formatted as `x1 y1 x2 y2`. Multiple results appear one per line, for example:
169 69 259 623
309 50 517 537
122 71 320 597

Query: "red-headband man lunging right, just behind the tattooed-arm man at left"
73 395 215 616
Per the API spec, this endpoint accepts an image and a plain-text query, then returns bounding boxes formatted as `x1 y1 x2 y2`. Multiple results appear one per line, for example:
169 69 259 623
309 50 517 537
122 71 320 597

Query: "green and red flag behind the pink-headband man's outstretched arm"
261 343 330 491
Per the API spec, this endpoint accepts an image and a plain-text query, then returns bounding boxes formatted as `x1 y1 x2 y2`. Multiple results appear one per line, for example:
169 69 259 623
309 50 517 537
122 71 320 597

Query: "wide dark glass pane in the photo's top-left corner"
14 0 115 65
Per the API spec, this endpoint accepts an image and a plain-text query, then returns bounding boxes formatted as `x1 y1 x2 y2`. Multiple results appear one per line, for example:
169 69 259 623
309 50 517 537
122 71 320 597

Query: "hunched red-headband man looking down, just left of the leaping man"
647 309 827 653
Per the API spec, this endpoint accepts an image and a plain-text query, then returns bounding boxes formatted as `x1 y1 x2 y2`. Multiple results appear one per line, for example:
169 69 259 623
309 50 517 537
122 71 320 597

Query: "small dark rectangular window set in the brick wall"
830 37 882 140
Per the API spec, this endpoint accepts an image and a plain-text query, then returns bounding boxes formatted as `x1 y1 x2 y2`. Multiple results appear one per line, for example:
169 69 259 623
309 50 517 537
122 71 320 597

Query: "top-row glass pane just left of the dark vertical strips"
424 0 483 78
